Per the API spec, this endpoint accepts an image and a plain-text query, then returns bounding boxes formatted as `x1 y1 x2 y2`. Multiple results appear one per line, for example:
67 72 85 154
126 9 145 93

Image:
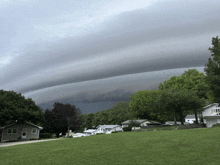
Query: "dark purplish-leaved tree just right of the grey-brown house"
45 102 82 137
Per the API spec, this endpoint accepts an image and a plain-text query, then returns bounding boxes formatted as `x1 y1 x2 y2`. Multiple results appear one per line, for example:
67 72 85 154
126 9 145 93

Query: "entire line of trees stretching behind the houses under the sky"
0 36 220 136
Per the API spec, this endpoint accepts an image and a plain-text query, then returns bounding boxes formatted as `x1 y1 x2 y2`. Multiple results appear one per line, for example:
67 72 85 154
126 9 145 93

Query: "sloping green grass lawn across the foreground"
0 127 220 165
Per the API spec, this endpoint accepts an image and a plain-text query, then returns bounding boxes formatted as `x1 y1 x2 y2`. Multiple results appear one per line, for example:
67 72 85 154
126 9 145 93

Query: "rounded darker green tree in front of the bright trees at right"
154 88 205 124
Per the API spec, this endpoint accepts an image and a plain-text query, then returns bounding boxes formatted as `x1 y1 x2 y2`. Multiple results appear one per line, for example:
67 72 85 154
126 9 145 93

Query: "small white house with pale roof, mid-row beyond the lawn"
96 125 122 134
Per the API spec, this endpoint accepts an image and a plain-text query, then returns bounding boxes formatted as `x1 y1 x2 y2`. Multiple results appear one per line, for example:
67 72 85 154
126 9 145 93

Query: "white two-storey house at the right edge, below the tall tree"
202 103 220 127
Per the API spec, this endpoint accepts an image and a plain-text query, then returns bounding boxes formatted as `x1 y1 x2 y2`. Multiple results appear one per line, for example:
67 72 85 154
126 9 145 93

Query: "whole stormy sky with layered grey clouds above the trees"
0 0 220 113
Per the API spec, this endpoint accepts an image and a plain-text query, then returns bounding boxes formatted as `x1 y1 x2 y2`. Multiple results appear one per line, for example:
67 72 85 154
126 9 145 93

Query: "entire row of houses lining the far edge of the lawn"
0 103 220 142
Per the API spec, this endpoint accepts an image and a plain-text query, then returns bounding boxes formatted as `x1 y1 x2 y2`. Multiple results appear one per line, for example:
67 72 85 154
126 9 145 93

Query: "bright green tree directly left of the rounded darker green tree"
129 90 160 120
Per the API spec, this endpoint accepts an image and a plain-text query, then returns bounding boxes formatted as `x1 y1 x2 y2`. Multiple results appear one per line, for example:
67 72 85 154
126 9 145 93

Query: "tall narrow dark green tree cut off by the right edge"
204 36 220 103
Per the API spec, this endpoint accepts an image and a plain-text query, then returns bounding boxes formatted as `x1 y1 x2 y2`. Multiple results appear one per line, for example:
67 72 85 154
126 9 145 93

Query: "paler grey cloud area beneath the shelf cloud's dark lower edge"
21 67 203 104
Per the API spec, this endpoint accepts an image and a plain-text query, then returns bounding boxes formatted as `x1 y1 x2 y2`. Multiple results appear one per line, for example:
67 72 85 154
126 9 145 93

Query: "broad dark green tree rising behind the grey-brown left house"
0 90 44 126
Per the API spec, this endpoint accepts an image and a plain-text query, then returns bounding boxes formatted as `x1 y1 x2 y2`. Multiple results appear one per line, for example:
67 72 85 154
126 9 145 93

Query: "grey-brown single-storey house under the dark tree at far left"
0 123 43 142
